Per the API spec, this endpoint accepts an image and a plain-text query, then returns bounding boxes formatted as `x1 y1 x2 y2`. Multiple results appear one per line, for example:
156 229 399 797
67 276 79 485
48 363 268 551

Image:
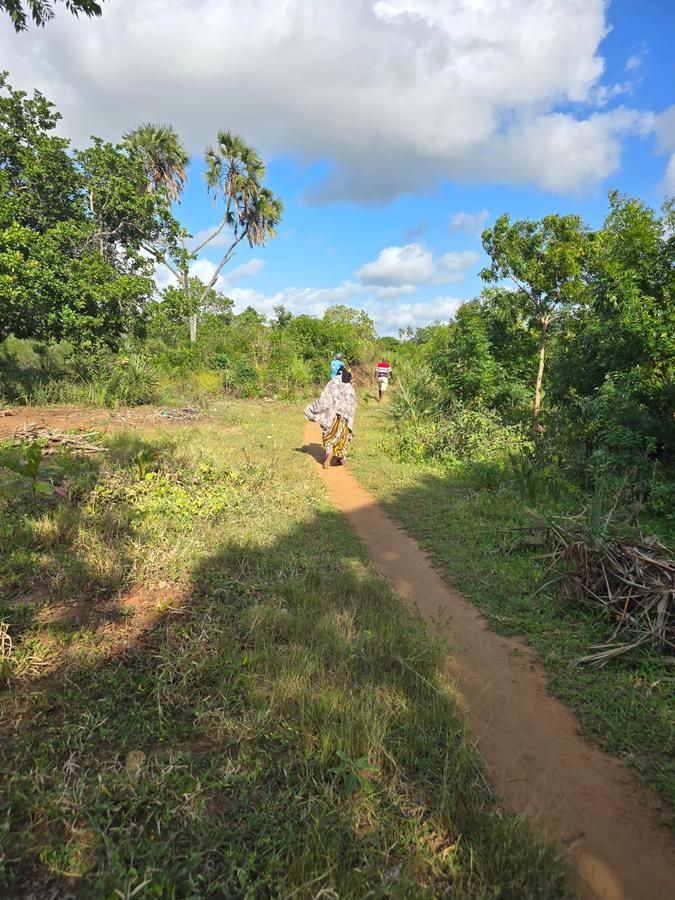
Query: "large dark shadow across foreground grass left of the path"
0 460 565 900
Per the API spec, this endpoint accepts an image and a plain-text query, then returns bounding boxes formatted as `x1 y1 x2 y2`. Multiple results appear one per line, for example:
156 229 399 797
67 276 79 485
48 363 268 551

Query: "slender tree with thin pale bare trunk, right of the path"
480 213 586 434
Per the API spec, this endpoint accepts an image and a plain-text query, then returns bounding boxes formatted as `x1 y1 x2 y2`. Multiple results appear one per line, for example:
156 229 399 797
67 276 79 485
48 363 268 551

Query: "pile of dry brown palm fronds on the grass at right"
540 518 675 667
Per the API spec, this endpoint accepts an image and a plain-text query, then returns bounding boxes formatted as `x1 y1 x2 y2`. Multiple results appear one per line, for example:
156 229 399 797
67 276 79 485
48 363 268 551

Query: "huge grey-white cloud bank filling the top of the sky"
0 0 640 203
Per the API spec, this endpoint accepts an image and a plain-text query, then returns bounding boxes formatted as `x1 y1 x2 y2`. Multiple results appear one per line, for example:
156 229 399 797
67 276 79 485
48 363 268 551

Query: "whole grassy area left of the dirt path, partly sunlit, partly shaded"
0 402 568 900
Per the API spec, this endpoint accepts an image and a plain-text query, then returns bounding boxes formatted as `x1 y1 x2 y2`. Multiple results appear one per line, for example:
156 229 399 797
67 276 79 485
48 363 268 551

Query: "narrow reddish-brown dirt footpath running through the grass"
305 424 675 900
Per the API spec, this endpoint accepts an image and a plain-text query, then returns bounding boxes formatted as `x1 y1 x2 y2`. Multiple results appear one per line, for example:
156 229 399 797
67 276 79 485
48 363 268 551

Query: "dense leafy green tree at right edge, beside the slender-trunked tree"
552 192 675 467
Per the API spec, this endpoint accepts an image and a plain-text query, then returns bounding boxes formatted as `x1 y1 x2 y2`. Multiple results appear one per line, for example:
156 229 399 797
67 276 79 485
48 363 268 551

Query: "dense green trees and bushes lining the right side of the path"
394 193 675 521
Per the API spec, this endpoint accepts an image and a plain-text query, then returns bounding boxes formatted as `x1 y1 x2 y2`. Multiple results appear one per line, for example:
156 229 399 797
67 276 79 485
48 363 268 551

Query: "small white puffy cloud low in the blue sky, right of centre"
356 244 478 288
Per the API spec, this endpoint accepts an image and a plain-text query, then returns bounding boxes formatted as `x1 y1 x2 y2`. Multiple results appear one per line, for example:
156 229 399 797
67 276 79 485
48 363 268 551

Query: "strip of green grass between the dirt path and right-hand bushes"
352 402 675 826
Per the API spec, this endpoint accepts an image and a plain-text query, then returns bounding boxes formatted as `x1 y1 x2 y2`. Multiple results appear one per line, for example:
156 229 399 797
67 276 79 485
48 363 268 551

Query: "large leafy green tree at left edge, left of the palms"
0 76 178 349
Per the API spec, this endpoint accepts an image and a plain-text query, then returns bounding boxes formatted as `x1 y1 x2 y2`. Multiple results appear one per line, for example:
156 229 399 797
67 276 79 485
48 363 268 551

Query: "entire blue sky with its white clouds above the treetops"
0 0 675 333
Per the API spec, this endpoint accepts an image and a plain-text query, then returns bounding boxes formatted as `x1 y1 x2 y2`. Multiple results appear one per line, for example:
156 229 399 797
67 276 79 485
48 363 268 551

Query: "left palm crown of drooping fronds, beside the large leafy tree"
123 122 190 200
